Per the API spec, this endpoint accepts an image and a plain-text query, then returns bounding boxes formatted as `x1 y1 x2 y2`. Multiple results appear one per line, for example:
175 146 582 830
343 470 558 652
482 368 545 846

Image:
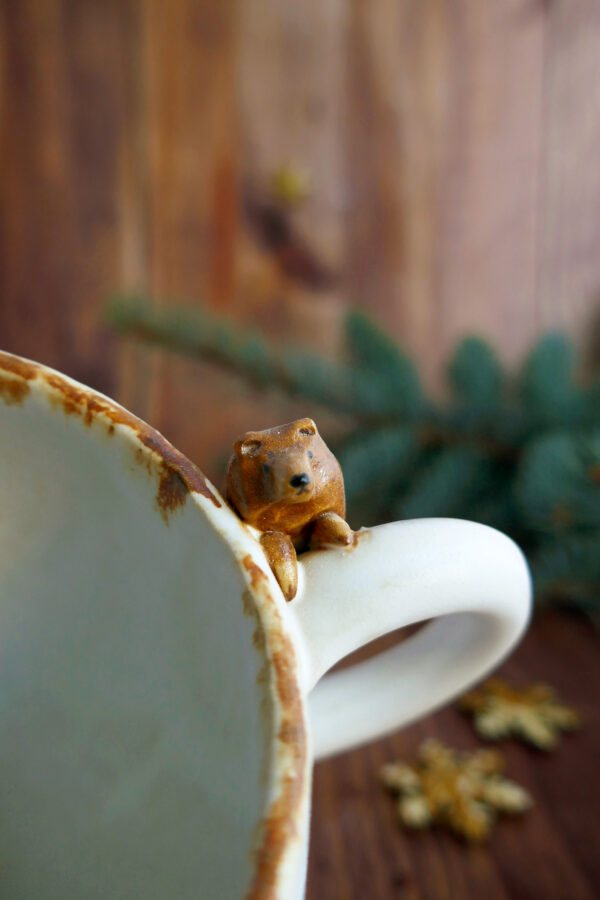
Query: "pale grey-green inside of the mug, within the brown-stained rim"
0 358 304 900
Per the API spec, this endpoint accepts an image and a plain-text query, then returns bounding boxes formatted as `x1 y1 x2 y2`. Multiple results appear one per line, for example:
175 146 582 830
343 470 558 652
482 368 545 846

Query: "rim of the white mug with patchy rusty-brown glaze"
0 351 309 900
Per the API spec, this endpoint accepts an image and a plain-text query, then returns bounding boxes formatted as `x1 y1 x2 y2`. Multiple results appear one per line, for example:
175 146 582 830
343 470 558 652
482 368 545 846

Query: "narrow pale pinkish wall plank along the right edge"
537 0 600 333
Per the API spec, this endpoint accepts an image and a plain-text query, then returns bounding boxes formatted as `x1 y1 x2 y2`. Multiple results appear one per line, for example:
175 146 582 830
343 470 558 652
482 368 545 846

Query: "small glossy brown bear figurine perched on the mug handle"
225 419 354 600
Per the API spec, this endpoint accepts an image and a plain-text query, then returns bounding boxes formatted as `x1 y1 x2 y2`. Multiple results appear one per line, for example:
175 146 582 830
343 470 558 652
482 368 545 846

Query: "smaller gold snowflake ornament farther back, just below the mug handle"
460 678 579 750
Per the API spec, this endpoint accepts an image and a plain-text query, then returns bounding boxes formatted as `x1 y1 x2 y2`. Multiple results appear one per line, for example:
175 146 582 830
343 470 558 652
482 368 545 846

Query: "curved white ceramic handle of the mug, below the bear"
288 519 532 759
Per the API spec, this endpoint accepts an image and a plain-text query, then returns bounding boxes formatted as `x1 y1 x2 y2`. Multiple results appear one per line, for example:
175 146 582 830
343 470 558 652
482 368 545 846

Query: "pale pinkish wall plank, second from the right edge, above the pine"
438 0 548 364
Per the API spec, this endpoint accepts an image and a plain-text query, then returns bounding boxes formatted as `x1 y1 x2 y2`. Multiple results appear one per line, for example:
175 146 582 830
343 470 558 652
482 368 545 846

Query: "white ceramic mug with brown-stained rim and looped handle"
0 354 530 900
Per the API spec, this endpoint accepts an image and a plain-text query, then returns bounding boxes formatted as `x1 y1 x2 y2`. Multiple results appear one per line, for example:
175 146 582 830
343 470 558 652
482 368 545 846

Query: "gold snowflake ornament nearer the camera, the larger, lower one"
381 739 532 842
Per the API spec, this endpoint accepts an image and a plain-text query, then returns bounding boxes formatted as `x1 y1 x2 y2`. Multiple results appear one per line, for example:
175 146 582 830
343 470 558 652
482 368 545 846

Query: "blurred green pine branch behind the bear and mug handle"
109 298 600 621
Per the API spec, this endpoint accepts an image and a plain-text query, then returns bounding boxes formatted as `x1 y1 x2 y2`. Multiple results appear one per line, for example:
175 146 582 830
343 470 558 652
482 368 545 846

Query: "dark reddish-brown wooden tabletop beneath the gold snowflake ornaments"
307 612 600 900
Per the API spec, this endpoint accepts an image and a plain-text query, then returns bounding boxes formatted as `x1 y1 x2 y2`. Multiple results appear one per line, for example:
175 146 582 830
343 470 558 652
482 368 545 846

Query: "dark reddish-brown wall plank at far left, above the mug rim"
0 0 124 390
